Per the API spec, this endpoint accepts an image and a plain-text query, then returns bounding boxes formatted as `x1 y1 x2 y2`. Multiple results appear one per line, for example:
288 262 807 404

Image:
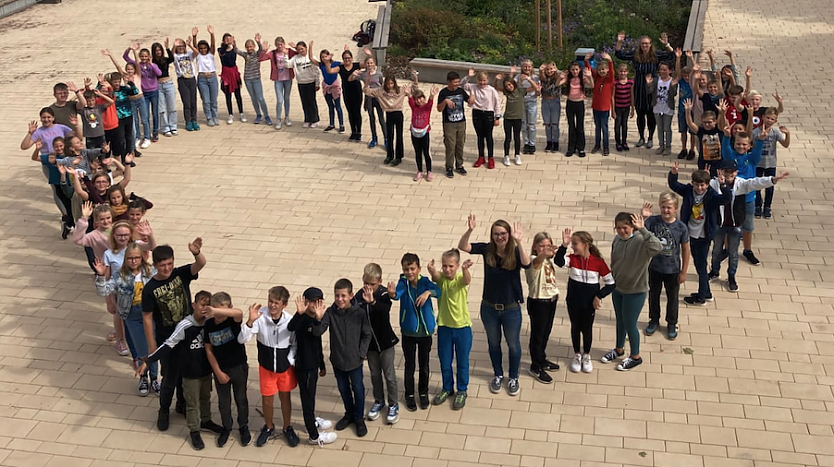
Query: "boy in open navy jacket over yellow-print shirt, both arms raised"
668 162 732 306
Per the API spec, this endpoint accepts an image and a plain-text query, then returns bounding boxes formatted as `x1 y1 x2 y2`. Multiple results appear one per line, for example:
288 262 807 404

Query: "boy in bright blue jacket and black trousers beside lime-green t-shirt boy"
388 253 440 412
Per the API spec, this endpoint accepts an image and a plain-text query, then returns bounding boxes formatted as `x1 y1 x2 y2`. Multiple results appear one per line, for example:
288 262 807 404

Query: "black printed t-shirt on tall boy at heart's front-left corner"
142 264 197 336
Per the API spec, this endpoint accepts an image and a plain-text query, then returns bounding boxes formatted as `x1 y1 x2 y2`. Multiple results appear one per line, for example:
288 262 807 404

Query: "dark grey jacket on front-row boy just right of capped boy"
313 304 371 371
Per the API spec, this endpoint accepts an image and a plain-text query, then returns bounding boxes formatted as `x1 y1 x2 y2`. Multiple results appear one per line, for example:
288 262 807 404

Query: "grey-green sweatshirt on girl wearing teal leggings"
611 227 663 294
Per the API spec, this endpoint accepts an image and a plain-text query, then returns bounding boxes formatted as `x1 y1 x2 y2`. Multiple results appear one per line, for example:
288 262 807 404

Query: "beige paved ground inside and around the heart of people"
0 0 834 467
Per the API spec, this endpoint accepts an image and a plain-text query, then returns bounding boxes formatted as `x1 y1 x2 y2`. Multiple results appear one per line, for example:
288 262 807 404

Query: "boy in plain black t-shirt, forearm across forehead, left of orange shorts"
205 292 252 448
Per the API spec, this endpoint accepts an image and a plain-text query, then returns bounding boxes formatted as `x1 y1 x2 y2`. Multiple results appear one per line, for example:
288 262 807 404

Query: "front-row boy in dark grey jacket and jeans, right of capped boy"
313 278 373 438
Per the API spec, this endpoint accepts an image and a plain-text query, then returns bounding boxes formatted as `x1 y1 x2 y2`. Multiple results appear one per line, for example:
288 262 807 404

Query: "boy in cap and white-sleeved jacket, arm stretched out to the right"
709 159 789 292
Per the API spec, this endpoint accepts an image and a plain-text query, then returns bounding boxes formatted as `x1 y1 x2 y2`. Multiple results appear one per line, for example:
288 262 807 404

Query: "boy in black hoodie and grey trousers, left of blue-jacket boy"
355 263 400 425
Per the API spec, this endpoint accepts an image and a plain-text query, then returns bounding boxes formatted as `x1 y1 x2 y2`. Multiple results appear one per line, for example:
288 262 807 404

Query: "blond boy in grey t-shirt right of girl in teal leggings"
645 191 690 340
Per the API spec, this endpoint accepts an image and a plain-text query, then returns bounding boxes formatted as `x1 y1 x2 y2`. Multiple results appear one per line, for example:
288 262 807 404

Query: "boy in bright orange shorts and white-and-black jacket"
238 286 298 447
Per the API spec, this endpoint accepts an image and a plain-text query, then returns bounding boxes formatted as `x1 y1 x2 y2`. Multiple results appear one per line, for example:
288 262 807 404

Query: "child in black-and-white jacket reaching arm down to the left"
136 290 223 451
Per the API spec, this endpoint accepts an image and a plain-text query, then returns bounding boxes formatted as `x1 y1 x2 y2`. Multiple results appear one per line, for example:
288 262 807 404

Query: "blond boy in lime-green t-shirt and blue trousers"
428 248 472 410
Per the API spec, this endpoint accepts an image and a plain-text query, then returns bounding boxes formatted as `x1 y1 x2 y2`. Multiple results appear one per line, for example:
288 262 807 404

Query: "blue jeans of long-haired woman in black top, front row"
481 302 521 378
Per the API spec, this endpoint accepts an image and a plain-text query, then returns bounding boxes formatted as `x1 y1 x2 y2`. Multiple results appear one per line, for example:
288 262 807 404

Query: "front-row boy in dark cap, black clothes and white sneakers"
287 287 336 446
